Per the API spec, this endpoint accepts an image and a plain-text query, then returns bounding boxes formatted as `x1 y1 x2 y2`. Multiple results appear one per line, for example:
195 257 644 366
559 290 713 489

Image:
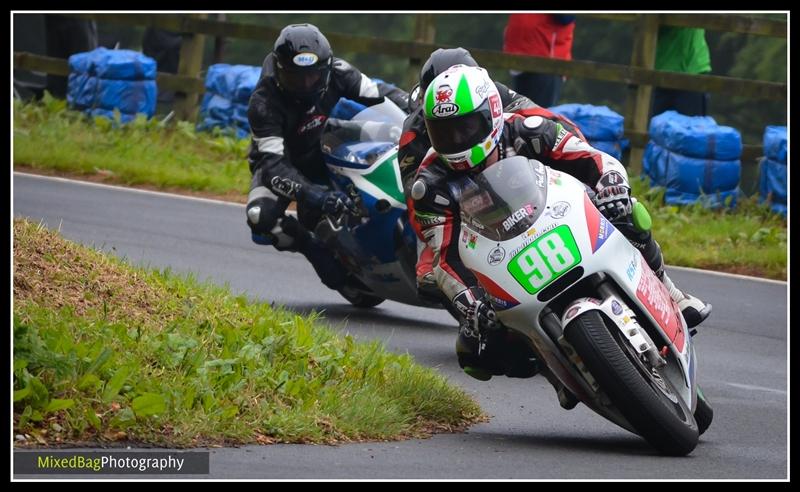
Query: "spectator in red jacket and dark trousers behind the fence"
503 14 575 108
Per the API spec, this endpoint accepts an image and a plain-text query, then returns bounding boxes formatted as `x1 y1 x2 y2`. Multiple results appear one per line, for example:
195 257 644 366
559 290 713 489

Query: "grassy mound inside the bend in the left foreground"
13 221 484 447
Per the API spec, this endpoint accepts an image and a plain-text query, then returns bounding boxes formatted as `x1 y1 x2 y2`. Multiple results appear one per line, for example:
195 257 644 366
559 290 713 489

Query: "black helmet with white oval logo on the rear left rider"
272 24 333 104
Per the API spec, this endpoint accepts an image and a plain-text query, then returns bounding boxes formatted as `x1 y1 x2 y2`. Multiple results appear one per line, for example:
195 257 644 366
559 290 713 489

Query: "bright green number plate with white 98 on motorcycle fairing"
508 225 581 294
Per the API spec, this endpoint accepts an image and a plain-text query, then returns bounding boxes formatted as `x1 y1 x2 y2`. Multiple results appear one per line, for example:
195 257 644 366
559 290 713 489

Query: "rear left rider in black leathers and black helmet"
246 24 408 290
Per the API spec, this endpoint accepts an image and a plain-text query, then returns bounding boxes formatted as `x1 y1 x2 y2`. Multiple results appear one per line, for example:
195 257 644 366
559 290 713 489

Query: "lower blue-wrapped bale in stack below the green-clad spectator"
643 141 742 206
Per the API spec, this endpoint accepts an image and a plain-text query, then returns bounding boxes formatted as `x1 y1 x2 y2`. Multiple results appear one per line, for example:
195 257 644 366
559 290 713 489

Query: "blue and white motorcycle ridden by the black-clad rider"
273 98 458 316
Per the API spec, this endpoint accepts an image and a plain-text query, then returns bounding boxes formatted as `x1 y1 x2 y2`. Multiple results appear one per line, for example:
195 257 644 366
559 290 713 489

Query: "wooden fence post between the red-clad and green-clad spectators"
625 14 660 175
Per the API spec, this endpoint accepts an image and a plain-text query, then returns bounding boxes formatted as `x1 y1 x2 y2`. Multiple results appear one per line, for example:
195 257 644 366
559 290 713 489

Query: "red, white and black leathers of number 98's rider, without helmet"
411 114 708 379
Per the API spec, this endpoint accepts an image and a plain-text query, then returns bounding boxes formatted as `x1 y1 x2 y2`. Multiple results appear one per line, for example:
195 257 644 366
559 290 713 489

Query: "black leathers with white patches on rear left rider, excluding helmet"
247 53 408 289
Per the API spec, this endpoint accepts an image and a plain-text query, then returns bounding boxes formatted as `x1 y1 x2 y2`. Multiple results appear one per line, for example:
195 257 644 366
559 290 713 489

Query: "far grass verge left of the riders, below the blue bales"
14 96 250 196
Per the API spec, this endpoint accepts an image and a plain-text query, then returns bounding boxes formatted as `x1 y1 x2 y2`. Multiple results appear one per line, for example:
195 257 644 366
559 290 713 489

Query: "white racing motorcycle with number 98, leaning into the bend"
450 156 713 455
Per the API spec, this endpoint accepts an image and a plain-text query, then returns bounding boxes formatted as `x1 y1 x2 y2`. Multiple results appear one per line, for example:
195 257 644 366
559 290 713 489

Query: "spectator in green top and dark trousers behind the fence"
651 26 711 116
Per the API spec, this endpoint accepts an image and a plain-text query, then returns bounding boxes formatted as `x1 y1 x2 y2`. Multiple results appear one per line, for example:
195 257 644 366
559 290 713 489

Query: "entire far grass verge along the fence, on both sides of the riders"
14 97 788 280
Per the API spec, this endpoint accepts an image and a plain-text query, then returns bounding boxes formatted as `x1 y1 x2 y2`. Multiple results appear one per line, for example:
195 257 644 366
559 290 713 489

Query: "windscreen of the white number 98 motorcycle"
450 156 547 241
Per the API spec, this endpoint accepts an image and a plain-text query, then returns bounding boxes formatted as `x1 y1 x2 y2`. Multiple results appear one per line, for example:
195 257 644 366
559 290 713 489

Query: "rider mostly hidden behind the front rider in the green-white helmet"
397 47 583 306
